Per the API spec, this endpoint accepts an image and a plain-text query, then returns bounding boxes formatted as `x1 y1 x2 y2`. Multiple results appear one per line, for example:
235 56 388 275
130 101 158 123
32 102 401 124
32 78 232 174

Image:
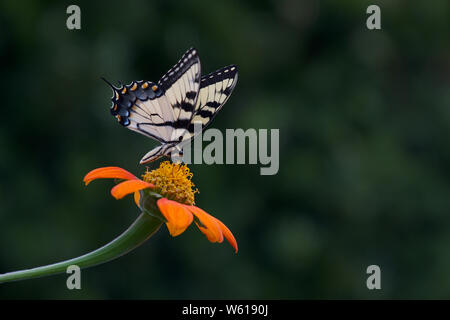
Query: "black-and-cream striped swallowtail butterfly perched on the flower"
103 48 238 164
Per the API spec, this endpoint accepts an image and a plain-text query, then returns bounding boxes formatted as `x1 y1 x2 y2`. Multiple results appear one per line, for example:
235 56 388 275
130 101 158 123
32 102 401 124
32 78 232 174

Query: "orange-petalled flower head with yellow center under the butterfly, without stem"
83 161 238 252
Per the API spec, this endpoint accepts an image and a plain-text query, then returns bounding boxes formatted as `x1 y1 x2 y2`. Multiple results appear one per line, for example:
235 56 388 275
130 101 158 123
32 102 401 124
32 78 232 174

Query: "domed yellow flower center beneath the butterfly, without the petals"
142 161 199 205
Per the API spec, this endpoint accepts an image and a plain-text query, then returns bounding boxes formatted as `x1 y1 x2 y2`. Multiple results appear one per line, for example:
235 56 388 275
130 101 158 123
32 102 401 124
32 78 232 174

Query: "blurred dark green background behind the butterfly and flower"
0 0 450 299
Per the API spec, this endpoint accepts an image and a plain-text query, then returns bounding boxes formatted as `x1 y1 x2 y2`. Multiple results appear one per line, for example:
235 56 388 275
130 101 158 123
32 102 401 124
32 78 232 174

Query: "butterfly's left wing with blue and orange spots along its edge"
110 48 201 162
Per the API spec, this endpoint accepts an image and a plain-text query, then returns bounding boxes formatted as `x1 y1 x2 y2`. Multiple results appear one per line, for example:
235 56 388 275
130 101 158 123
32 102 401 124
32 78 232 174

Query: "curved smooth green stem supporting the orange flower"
0 213 163 283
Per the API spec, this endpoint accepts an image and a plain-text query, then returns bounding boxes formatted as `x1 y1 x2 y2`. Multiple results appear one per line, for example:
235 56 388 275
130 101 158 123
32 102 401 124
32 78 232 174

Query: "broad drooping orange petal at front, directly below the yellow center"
156 198 194 237
